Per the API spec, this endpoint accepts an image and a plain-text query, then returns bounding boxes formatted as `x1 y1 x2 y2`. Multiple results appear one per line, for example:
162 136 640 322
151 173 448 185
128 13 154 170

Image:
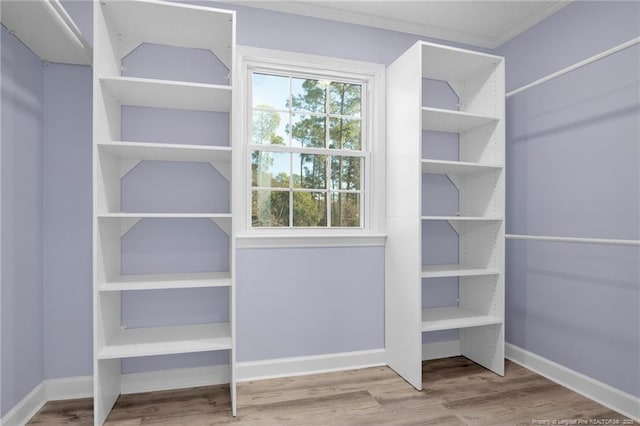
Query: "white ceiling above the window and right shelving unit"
227 0 571 49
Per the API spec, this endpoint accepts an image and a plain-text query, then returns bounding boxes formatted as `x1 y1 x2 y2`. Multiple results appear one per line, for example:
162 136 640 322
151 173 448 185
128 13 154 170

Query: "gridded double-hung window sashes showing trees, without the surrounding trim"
249 71 367 228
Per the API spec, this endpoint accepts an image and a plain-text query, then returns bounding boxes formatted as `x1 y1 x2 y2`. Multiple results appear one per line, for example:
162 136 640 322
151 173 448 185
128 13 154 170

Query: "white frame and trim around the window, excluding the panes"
232 46 386 247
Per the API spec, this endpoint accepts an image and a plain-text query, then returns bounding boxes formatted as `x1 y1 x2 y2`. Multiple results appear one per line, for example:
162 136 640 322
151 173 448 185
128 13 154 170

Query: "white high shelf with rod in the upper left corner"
2 0 93 65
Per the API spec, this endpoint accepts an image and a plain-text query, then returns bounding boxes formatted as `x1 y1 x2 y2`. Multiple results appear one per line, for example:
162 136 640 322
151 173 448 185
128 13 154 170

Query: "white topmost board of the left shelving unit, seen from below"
96 0 234 69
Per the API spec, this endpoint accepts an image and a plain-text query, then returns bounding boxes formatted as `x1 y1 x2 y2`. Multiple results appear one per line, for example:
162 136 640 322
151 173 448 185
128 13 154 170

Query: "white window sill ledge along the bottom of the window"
236 234 387 248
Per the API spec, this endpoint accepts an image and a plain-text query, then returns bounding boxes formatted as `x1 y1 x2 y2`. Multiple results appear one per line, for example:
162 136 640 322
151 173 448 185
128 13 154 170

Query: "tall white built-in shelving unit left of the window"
93 0 236 425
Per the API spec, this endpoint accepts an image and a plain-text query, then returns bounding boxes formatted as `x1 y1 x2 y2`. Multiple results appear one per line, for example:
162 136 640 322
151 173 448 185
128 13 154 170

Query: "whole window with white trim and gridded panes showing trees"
234 48 384 245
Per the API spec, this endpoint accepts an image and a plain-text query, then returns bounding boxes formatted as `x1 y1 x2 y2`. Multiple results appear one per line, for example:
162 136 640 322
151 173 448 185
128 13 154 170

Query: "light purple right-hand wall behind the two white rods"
497 2 640 396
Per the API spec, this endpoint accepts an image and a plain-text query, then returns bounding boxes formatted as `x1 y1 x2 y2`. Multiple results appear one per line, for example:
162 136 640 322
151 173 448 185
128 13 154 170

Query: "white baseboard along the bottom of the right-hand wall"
505 343 640 422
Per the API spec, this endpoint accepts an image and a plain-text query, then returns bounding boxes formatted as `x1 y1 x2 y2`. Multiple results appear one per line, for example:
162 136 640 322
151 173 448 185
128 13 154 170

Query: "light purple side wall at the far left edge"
0 27 44 416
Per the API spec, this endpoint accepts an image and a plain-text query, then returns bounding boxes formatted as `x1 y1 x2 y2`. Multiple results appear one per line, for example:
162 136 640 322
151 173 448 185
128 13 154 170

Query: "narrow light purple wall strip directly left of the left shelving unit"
43 64 93 379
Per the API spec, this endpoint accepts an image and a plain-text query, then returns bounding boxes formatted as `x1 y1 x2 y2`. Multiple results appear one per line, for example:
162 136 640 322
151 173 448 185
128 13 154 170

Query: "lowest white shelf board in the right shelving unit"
422 306 502 332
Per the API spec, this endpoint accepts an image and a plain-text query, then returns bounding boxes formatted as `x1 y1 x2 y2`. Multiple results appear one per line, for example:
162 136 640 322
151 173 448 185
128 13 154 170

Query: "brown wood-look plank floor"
28 357 637 426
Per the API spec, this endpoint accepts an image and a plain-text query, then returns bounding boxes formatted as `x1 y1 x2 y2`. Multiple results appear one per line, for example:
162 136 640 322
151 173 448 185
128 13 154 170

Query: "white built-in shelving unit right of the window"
385 42 505 389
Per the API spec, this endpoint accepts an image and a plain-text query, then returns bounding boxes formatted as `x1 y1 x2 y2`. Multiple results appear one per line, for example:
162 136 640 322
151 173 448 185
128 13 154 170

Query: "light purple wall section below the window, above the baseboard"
236 247 384 361
